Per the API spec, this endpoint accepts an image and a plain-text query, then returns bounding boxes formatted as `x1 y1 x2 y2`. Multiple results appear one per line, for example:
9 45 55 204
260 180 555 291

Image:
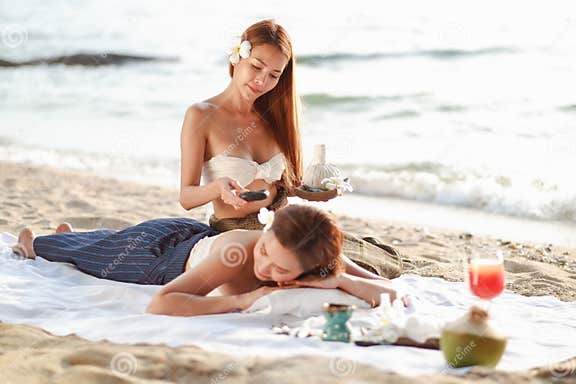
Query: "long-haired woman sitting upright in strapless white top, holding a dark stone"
180 20 402 278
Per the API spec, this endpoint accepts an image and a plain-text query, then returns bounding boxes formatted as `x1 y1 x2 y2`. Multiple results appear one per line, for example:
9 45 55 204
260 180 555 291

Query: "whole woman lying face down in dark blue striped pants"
14 205 396 316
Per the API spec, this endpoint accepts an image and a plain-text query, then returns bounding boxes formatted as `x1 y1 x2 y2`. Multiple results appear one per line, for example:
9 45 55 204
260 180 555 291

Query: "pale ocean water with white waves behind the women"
0 0 576 244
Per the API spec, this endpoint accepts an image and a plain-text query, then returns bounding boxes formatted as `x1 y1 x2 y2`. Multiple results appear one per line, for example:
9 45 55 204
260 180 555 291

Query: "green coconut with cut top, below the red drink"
440 306 507 368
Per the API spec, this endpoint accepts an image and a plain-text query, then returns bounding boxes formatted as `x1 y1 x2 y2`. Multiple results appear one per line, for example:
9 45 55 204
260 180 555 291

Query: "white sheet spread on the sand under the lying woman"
0 233 576 375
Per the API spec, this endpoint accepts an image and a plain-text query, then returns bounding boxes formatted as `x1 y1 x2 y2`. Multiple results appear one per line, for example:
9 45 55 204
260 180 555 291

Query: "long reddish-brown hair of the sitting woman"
228 20 302 187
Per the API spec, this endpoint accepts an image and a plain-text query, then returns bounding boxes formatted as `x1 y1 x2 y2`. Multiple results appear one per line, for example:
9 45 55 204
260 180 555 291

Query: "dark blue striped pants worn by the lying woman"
34 218 219 285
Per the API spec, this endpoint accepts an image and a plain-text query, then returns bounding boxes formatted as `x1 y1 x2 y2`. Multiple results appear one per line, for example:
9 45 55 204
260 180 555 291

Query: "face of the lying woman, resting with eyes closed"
254 231 304 283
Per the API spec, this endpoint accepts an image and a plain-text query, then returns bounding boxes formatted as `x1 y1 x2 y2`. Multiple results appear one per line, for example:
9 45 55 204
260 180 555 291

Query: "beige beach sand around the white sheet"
0 162 576 383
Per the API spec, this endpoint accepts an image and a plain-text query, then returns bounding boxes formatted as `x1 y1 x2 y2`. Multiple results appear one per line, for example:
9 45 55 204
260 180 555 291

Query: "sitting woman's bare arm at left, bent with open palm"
180 105 245 210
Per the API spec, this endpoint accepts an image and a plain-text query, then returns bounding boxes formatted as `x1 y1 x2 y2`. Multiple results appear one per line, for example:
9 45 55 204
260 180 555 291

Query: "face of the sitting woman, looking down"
234 44 288 100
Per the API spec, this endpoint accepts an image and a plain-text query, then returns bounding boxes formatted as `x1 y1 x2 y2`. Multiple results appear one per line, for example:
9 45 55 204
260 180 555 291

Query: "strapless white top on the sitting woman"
204 152 286 187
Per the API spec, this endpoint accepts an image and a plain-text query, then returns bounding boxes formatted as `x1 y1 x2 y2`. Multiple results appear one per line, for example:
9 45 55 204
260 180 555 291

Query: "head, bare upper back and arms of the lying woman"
146 205 396 316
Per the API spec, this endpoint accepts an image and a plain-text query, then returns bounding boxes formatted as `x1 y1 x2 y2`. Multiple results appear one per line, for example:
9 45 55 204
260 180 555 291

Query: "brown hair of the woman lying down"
271 205 344 278
